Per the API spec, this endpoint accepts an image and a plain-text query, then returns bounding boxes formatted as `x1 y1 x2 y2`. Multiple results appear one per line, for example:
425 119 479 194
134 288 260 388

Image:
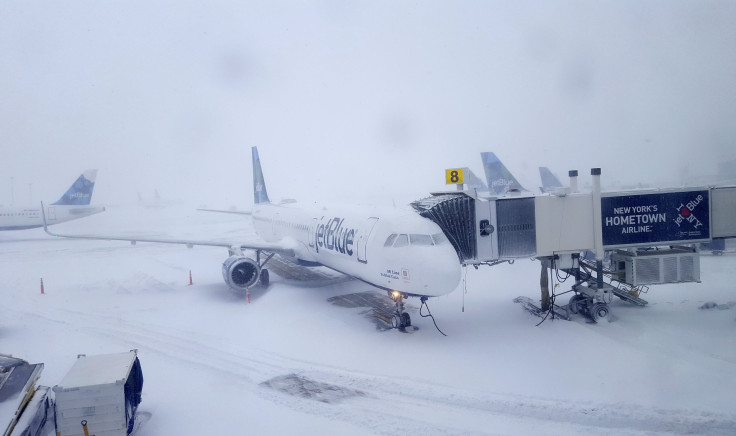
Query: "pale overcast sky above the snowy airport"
0 0 736 207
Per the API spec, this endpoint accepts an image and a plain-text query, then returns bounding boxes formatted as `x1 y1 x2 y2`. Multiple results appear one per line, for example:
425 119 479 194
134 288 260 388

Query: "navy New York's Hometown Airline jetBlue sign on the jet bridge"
601 191 710 246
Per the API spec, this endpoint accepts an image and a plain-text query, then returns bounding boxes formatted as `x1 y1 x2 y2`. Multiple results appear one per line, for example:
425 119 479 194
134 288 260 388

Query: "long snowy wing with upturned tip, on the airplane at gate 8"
41 203 296 257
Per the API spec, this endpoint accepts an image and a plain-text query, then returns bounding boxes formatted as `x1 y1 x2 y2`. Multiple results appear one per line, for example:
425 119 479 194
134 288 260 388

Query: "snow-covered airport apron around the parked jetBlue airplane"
0 207 736 436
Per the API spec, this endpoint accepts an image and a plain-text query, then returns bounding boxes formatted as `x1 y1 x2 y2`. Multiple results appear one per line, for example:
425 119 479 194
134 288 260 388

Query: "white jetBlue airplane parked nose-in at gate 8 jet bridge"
46 147 460 329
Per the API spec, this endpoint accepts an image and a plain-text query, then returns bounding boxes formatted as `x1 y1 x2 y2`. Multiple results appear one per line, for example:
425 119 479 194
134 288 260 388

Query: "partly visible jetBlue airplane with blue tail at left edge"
0 170 105 230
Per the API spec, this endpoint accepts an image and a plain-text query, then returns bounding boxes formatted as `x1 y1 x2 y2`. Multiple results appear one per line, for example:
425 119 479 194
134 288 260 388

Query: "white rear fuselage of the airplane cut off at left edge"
0 205 105 230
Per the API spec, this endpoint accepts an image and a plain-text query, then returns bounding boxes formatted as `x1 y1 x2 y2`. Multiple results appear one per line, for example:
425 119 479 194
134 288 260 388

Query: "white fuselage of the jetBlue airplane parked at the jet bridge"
253 204 460 297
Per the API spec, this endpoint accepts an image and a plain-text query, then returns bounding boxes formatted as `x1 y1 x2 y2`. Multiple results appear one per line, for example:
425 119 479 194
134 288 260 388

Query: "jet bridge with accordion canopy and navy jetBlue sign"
412 169 736 320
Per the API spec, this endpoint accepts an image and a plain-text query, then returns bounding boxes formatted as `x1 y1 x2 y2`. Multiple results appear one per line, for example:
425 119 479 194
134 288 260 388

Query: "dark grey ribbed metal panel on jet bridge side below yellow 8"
496 198 537 258
